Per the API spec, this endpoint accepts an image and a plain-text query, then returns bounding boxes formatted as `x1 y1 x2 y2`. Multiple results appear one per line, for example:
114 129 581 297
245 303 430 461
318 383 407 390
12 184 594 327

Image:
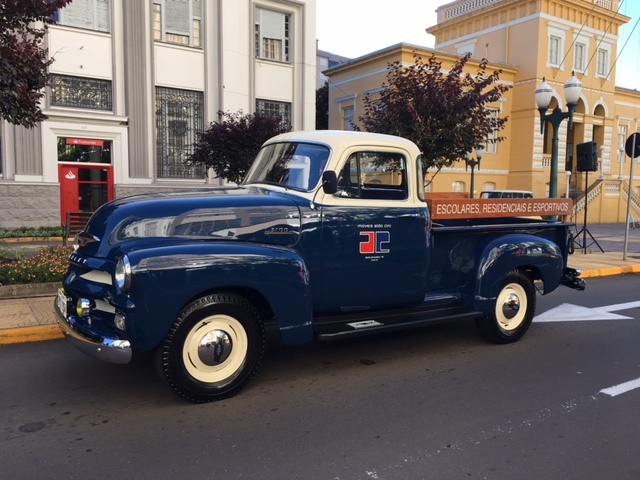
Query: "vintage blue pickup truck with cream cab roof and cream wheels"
55 131 584 402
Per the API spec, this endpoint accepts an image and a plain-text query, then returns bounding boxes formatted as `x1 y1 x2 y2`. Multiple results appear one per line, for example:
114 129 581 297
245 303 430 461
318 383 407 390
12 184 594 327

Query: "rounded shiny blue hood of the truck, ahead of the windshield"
79 187 300 257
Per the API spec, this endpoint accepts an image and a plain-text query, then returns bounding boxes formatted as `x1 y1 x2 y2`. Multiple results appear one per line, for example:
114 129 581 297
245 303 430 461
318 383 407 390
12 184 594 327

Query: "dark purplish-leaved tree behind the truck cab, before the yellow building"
359 52 511 178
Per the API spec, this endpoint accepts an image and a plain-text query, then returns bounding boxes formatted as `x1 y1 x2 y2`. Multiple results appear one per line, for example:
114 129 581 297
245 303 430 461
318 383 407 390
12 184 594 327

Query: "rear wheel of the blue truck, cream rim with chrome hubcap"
476 272 536 344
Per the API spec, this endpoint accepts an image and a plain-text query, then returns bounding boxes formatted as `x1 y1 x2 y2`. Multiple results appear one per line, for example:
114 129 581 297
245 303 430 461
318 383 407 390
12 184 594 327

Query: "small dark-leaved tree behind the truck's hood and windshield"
189 111 291 184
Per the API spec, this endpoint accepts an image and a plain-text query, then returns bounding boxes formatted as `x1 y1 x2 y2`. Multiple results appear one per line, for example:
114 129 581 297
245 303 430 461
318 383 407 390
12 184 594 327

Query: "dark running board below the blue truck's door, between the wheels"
314 305 482 341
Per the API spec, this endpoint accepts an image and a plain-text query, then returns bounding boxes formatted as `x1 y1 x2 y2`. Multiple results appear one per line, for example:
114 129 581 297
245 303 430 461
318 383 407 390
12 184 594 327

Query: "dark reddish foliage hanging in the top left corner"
0 0 71 128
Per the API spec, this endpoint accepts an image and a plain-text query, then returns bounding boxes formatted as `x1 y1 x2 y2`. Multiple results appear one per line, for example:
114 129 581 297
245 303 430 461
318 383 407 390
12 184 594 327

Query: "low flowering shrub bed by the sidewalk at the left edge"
0 246 72 285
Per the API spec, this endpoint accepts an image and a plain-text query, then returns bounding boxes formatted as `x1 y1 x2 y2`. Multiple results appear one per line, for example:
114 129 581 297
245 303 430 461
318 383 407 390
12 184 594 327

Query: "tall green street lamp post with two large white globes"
536 72 582 198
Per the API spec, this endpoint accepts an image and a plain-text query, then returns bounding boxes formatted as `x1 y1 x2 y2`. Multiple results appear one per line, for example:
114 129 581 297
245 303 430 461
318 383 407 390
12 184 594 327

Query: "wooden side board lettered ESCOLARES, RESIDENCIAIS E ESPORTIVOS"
427 198 573 220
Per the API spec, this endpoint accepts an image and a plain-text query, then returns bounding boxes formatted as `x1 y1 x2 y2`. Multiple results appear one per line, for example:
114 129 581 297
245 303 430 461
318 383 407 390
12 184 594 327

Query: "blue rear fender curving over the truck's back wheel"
471 234 564 313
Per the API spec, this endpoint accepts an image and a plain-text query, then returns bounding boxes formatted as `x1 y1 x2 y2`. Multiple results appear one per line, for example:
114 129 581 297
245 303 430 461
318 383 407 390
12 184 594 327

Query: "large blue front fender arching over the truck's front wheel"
122 242 313 350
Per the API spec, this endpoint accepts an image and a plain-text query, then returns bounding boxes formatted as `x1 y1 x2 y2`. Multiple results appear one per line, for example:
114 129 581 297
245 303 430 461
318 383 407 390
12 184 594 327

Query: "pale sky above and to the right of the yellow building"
316 0 640 90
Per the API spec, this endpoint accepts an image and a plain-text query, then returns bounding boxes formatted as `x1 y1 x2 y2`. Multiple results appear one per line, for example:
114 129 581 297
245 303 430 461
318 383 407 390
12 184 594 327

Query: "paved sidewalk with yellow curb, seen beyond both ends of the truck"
0 223 640 345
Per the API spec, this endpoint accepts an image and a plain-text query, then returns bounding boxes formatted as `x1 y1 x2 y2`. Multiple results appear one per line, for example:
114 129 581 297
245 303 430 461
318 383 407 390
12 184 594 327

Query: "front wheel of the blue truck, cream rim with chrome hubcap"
156 294 265 403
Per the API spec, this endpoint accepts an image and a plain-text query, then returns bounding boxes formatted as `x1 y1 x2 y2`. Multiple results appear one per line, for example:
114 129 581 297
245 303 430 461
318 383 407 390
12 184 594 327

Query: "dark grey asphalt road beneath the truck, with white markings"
0 275 640 480
